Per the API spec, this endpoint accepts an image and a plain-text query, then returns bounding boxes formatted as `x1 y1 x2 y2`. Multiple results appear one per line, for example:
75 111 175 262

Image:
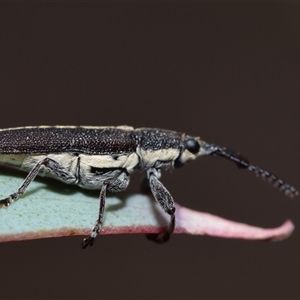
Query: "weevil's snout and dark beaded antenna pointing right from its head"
204 144 299 198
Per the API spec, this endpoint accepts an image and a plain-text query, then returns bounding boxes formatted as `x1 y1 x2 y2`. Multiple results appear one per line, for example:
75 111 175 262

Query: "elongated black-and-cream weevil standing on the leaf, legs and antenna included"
0 126 298 248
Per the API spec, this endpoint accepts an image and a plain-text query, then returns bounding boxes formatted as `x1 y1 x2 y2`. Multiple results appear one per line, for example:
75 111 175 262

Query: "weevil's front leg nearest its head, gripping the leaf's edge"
147 169 175 243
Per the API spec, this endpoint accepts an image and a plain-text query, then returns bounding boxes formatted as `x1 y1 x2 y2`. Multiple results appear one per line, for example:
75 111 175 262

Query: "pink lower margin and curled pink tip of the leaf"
0 199 294 242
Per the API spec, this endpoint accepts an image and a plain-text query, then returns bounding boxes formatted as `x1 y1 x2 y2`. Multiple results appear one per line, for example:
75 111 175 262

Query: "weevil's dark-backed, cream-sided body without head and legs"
0 126 202 189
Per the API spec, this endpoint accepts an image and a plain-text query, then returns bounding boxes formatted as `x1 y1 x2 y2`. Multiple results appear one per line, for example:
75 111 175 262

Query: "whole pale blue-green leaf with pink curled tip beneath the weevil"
0 173 294 242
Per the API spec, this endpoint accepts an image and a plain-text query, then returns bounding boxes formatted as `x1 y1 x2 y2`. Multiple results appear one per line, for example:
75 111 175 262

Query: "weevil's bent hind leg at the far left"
0 157 73 207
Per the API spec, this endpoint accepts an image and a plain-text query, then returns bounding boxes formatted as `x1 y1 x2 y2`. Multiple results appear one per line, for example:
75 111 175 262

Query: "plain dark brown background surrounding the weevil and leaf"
0 2 300 299
